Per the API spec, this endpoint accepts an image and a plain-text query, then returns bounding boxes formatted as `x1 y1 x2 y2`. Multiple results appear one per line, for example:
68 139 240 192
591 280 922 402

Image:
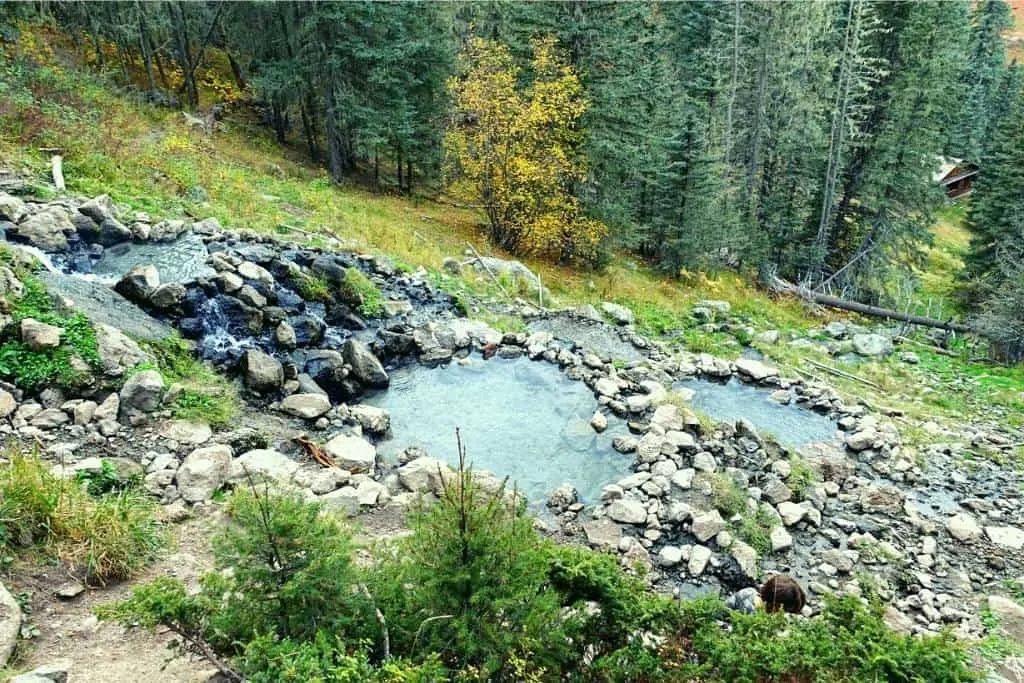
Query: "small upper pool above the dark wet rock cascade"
92 232 215 283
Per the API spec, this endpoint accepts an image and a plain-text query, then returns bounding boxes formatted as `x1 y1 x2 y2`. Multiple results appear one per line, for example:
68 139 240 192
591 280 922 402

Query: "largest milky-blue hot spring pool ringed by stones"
366 356 633 507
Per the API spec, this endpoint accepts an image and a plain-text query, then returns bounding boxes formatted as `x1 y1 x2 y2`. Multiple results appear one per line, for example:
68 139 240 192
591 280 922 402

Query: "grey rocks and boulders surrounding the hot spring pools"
0 189 1024 671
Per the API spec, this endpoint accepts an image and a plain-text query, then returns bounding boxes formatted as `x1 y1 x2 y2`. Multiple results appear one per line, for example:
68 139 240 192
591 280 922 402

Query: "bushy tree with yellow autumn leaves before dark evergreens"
445 38 607 263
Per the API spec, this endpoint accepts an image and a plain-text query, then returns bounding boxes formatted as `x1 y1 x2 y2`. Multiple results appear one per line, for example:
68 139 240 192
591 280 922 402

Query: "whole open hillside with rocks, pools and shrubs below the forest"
0 13 1024 681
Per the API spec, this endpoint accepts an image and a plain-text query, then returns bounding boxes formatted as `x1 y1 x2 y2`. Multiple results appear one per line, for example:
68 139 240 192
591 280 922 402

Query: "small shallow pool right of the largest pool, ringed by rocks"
675 378 836 446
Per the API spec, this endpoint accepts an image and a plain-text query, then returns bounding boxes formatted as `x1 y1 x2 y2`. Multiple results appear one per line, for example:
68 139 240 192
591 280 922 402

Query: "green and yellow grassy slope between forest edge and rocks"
6 21 1024 448
